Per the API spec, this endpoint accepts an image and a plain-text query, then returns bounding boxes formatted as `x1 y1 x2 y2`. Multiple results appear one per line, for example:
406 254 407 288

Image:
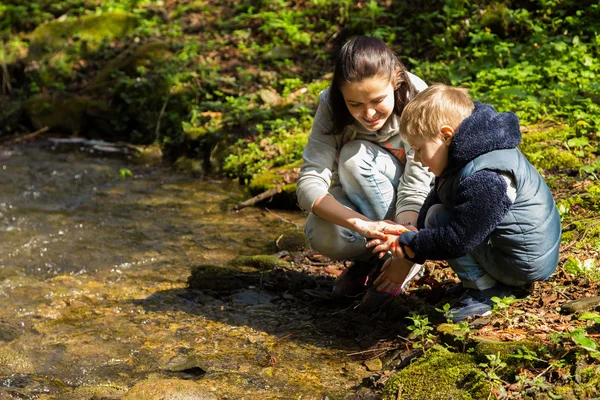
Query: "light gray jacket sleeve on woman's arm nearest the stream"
296 90 338 211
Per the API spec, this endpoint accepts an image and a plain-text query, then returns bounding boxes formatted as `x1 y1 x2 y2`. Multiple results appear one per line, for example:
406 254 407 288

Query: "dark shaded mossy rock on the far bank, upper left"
23 96 111 135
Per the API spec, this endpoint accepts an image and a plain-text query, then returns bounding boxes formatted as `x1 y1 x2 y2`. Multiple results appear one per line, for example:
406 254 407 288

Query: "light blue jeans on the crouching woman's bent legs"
305 140 404 261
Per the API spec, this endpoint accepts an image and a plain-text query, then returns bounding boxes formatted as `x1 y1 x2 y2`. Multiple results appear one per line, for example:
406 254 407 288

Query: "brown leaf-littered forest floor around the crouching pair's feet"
260 171 600 399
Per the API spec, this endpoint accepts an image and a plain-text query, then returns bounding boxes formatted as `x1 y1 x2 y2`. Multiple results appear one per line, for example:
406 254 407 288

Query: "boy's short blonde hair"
400 83 475 140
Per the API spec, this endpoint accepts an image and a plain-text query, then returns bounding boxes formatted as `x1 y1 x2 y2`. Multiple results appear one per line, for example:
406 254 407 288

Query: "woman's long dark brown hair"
328 36 417 135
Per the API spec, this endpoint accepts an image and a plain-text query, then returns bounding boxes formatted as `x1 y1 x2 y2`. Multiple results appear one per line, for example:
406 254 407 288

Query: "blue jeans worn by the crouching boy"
425 204 527 290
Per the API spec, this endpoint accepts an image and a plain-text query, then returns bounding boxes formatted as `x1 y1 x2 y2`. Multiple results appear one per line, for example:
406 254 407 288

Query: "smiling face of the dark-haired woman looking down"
340 76 394 131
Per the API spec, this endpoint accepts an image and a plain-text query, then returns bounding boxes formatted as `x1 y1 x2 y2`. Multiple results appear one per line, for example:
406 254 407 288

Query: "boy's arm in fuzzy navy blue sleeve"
399 170 512 262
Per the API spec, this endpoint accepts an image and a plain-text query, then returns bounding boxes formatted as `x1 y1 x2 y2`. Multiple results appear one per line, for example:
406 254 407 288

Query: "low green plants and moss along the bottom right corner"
383 310 600 399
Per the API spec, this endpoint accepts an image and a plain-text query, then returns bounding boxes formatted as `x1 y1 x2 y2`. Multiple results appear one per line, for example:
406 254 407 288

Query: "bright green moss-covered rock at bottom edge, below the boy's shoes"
383 346 492 400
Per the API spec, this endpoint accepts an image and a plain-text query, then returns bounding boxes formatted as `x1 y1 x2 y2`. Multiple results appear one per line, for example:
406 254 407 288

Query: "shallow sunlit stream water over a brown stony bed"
0 144 368 400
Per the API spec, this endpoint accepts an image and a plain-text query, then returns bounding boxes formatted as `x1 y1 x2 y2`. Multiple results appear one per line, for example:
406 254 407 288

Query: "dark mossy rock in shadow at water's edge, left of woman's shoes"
187 264 261 292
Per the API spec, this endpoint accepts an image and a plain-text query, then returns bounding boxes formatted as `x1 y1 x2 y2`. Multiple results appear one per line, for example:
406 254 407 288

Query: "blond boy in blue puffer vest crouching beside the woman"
367 84 561 322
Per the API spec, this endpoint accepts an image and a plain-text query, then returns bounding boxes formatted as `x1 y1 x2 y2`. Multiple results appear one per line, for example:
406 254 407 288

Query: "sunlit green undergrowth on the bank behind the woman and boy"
0 0 600 207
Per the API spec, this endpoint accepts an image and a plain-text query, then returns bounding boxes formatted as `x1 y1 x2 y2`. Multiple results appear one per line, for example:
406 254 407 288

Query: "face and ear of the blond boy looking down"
406 126 454 176
